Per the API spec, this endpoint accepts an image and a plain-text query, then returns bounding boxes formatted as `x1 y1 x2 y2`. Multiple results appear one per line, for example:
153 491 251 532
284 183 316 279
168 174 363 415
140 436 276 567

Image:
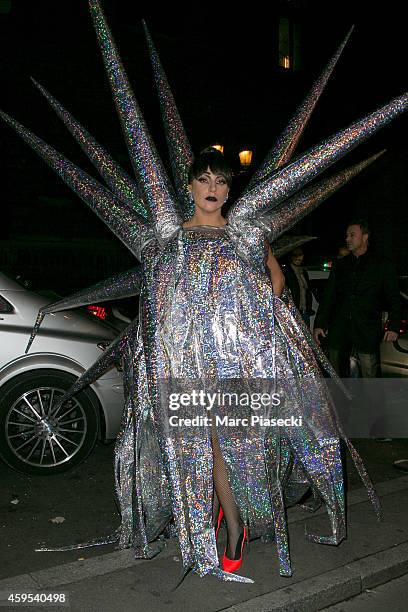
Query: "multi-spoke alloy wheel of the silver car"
0 370 98 476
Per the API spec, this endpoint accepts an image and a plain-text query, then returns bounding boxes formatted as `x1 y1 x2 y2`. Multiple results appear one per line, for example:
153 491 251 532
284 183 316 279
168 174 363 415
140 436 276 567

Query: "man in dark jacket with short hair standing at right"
313 219 401 377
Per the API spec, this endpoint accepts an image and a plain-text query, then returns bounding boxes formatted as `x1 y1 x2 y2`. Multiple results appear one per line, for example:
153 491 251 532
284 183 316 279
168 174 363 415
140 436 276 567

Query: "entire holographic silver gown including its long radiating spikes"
0 0 408 582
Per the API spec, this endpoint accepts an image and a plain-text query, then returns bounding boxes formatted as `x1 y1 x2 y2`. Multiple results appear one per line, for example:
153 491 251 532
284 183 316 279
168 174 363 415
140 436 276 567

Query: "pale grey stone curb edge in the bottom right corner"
223 542 408 612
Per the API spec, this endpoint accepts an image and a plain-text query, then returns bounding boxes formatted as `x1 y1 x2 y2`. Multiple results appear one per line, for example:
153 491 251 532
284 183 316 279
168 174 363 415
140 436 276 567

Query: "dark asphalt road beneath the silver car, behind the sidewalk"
0 439 408 579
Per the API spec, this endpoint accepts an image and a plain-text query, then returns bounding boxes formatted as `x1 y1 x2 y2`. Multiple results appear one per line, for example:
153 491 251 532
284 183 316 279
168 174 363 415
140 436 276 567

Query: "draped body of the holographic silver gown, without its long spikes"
111 225 374 580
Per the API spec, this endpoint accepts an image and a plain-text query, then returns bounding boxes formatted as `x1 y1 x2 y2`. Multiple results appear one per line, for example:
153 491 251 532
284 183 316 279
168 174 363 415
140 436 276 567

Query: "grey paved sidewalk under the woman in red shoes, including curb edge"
0 476 408 612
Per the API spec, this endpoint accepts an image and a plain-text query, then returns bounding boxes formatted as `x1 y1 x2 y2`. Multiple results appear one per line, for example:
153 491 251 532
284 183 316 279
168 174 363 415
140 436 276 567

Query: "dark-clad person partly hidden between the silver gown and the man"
282 247 313 327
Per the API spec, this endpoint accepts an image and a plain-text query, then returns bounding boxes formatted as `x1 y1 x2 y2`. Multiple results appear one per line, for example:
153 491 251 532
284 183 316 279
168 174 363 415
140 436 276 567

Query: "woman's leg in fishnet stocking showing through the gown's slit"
212 428 244 559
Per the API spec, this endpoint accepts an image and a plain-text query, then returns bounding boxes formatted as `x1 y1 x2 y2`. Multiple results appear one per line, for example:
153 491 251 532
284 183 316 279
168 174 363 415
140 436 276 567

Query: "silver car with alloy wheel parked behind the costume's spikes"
0 273 123 475
